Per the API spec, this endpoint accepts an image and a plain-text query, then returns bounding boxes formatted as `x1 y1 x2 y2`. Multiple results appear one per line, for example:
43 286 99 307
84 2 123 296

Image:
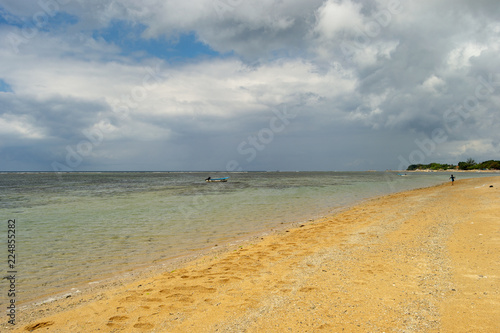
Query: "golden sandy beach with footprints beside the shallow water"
7 177 500 332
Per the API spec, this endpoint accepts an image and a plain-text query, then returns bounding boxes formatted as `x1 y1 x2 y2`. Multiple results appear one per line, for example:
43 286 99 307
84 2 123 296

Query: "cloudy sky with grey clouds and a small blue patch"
0 0 500 171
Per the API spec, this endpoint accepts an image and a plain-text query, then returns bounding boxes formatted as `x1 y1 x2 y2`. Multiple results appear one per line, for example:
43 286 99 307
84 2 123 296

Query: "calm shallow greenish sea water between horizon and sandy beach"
0 172 494 304
